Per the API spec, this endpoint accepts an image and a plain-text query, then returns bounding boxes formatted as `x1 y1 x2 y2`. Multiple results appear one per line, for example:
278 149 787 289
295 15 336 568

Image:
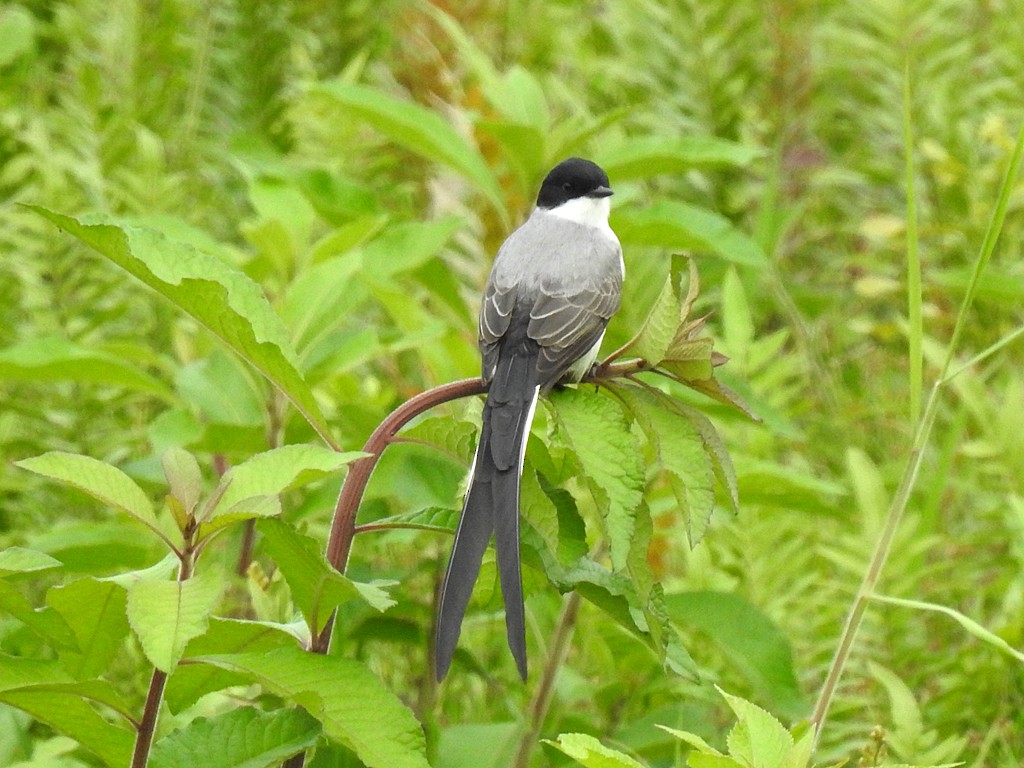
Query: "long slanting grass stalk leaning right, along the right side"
811 120 1024 744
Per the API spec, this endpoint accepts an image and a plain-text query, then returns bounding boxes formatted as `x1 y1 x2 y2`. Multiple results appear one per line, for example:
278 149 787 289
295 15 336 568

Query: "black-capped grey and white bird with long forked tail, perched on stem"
434 158 626 682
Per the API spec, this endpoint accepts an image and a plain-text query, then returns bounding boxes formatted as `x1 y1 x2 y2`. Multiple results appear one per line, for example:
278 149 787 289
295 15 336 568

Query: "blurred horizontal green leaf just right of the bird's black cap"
601 135 761 181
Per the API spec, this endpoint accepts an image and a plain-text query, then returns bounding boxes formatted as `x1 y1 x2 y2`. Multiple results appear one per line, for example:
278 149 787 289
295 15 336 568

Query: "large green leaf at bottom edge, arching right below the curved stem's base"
197 648 429 768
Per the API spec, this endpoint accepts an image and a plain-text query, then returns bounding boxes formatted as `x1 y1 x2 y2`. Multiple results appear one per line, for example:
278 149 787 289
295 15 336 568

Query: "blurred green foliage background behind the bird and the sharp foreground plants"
0 0 1024 766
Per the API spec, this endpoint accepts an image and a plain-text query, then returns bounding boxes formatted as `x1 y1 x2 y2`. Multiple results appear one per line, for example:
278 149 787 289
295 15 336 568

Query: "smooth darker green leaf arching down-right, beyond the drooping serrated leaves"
665 590 807 719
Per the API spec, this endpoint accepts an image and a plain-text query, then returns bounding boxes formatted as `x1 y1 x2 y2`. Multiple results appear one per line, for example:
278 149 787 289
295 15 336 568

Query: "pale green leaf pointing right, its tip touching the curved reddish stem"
214 444 366 516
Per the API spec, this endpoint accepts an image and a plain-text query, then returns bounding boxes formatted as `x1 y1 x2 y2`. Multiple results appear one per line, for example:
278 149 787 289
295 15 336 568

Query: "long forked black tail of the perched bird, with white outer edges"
434 356 540 681
